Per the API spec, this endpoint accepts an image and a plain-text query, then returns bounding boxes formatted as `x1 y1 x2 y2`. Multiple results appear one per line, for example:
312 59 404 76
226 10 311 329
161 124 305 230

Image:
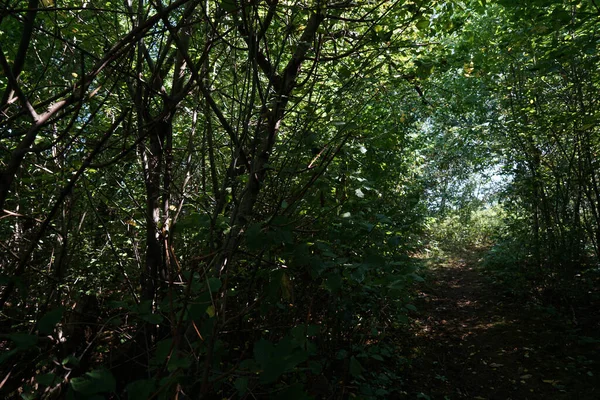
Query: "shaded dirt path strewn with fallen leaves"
405 252 600 400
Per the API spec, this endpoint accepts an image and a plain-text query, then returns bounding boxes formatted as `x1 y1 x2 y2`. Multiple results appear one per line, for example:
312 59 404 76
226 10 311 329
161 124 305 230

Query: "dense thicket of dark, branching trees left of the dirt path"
0 0 432 398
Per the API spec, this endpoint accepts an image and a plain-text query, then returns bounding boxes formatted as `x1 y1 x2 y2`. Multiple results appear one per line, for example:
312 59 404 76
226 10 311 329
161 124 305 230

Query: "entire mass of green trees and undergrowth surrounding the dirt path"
0 0 600 399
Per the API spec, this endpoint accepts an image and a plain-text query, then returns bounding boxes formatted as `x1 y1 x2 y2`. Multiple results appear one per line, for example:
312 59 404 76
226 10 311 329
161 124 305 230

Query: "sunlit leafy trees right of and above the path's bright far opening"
414 1 599 294
